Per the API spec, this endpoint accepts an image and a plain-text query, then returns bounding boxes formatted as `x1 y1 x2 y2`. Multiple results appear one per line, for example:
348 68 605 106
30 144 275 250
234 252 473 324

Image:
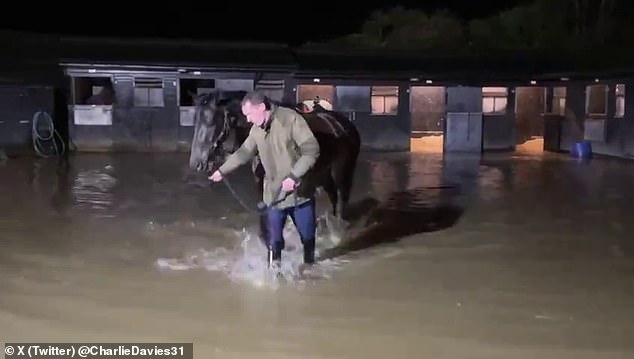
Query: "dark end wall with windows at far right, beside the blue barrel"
561 79 634 158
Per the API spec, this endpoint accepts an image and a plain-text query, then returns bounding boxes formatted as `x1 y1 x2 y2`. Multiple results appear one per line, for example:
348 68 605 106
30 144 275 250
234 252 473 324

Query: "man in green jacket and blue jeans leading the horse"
209 91 319 266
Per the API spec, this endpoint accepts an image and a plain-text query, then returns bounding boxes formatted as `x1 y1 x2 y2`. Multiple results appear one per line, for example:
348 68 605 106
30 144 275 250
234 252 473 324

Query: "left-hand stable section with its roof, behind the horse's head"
60 38 294 152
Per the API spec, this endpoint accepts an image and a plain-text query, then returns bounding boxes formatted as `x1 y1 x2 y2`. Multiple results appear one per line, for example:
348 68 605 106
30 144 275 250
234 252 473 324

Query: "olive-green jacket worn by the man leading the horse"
218 105 319 208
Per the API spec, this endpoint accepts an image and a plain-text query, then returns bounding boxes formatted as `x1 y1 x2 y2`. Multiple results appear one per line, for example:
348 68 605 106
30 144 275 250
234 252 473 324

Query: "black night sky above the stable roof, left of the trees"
0 0 525 44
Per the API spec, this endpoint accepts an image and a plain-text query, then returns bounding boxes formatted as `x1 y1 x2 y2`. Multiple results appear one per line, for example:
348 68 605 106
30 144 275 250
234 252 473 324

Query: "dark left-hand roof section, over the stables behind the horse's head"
0 31 296 71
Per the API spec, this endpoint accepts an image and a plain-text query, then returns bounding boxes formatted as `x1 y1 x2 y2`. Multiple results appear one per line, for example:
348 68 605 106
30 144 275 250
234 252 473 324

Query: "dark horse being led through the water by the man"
189 91 361 240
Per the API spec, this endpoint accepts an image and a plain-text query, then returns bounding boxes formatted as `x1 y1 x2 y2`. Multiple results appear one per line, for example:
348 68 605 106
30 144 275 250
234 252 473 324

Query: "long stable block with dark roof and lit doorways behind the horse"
0 29 634 162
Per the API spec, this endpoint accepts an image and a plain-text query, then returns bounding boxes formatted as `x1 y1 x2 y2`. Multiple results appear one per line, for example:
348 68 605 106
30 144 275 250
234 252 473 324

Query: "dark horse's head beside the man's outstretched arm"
189 91 246 171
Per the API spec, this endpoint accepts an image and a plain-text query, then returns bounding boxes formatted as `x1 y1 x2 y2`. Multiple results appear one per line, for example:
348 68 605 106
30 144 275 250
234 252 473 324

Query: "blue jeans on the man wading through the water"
266 199 317 263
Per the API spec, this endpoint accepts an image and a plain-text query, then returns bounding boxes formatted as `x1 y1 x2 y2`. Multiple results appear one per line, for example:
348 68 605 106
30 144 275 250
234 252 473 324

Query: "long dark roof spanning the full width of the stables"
0 31 634 82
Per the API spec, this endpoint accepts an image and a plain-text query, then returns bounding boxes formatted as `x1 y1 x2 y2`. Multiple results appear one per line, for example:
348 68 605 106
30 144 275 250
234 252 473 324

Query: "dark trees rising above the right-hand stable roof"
320 0 634 51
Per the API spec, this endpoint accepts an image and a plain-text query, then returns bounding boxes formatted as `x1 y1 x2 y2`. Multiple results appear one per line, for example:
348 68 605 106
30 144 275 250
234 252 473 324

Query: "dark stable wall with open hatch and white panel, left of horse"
69 73 179 151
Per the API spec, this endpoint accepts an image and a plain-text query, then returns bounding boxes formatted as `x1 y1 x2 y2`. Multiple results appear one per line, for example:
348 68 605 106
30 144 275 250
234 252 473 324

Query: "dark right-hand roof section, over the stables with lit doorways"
293 47 634 81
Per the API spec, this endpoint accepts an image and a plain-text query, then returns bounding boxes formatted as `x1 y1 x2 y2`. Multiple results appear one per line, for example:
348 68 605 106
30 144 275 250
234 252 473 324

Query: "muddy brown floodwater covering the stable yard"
0 153 634 359
